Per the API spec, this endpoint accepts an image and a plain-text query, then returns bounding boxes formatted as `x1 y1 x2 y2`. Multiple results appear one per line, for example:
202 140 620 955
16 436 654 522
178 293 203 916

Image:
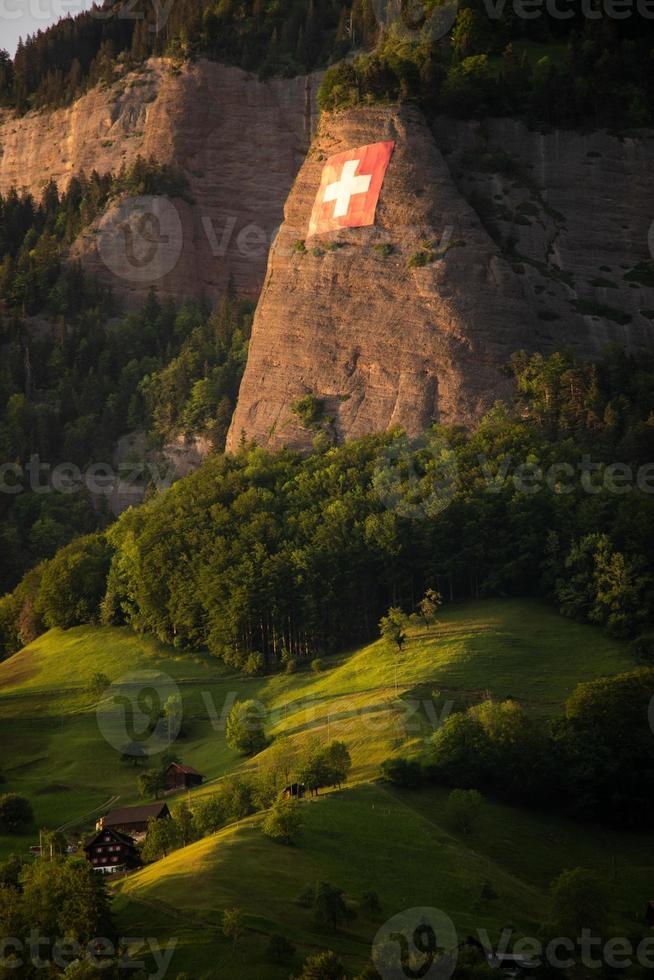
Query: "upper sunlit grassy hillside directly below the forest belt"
0 600 632 853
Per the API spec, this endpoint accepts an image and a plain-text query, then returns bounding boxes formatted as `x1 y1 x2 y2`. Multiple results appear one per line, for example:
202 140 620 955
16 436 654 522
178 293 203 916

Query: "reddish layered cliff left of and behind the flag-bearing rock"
0 59 317 304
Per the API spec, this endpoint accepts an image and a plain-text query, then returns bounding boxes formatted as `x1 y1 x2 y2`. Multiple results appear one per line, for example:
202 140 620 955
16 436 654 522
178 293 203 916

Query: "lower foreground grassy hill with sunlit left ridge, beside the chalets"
110 784 654 980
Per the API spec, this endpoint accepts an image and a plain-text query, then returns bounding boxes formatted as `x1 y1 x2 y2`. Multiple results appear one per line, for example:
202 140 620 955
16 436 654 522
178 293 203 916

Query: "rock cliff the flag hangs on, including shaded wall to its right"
228 107 654 450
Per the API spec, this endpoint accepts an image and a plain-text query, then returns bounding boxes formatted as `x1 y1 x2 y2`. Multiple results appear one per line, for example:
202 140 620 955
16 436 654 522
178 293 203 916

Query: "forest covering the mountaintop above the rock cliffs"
0 0 654 128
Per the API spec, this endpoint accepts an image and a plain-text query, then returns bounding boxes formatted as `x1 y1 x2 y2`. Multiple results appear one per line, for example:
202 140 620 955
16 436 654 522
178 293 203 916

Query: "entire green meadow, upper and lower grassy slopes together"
0 600 654 978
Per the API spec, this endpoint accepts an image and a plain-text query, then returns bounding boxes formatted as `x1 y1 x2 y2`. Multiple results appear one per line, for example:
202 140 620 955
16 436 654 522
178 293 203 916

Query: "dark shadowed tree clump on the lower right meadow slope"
382 668 654 827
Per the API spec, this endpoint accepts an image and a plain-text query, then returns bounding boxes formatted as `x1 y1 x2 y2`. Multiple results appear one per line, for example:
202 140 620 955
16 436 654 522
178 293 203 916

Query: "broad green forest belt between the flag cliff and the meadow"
5 350 654 669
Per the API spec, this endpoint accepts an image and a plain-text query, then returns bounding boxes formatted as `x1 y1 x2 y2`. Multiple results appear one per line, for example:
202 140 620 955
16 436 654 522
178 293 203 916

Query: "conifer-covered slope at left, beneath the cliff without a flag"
0 157 251 592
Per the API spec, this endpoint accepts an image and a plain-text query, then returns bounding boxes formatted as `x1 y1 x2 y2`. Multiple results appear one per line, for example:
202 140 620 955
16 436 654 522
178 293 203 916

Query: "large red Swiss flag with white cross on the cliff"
308 141 395 238
